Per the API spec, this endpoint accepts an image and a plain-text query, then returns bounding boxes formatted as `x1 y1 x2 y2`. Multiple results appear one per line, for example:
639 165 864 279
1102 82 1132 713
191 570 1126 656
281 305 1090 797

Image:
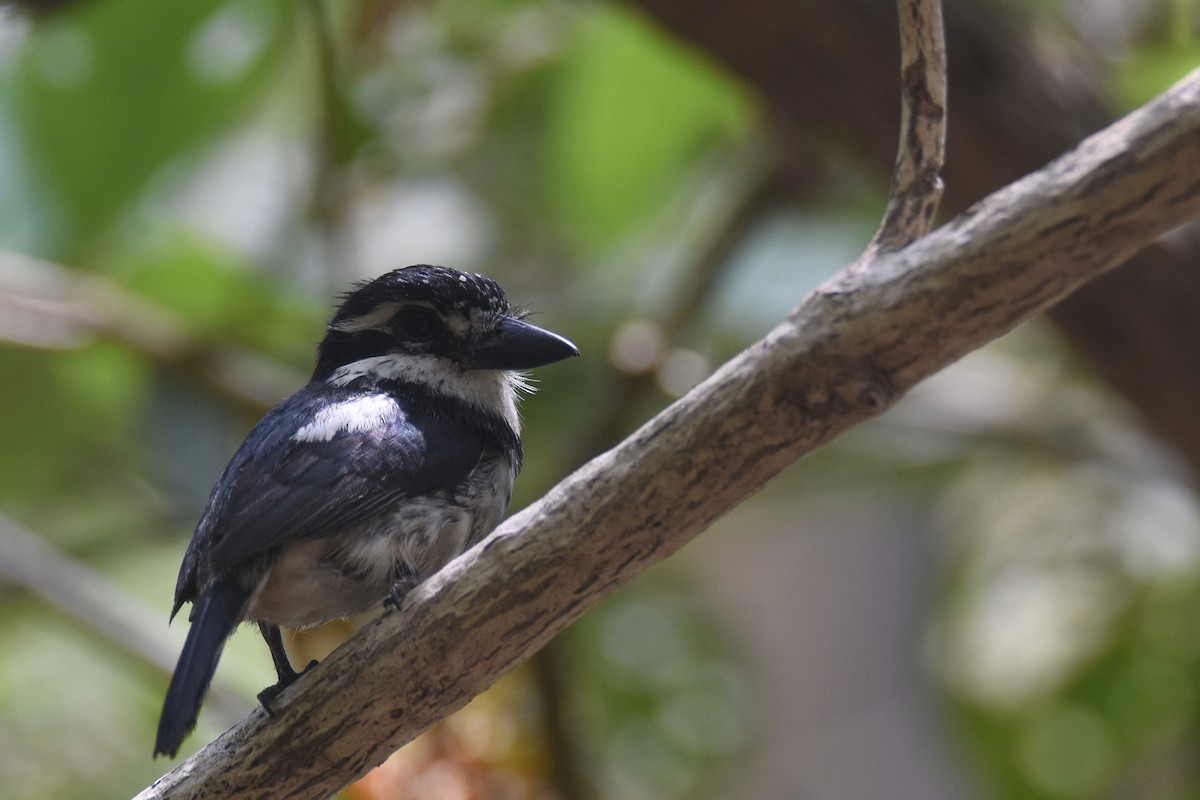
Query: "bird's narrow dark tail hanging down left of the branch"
154 578 250 758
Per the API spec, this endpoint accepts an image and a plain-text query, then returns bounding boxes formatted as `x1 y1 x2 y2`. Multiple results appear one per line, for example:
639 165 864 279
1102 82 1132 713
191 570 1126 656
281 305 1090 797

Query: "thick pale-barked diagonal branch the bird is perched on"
139 62 1200 799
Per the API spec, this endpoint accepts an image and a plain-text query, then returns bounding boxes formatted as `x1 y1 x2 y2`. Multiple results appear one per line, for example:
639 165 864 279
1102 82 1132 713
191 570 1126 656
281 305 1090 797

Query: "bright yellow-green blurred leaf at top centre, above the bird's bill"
546 6 752 246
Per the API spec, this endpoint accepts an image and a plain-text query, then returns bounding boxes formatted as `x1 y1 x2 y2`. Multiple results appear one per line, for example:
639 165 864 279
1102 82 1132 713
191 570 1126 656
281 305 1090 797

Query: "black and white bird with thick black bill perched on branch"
155 265 578 757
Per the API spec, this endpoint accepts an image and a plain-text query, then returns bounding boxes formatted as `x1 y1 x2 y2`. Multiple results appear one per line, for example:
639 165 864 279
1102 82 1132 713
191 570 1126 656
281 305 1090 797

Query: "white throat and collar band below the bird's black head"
329 353 524 434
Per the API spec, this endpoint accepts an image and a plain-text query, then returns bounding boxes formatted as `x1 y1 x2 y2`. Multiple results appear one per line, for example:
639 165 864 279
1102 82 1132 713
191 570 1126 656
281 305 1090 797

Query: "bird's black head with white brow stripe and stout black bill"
313 265 580 384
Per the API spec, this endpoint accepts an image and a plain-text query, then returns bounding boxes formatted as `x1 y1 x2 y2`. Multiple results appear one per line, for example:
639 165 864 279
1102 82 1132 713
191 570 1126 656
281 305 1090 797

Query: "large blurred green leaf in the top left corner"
11 0 292 255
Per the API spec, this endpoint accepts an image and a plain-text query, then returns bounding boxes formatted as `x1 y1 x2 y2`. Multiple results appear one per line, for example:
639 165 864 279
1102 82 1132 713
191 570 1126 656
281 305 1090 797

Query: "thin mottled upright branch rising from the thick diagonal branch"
866 0 946 258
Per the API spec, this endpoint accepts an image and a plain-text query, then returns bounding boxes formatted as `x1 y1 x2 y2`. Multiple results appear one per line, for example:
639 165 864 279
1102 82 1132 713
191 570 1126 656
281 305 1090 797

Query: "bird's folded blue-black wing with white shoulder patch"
175 386 485 609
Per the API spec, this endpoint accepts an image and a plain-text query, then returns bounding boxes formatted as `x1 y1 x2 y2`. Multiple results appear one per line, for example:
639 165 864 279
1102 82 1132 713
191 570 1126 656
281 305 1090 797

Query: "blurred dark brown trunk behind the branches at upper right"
635 0 1200 474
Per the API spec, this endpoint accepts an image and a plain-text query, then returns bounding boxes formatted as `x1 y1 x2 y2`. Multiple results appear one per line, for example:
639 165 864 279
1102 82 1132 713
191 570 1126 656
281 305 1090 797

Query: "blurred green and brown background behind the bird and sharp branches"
0 0 1200 800
